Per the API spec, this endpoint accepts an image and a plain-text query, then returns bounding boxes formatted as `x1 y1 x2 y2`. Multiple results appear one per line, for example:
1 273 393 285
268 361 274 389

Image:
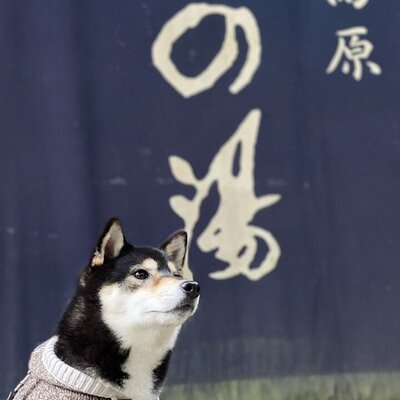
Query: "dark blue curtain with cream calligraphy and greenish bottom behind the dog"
0 0 400 400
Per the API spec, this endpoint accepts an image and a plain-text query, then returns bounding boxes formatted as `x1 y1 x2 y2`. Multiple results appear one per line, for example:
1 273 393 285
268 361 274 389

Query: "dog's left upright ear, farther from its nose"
90 218 125 267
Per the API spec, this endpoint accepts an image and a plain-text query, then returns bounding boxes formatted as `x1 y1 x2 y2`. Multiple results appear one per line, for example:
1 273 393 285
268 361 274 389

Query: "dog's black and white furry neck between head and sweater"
55 296 180 400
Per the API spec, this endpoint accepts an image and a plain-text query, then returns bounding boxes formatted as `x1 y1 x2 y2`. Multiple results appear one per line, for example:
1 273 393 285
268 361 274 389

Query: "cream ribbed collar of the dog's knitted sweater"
42 336 122 399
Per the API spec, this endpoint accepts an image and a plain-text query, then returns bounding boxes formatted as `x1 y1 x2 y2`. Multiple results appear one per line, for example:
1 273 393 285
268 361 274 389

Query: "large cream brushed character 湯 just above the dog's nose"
169 109 281 281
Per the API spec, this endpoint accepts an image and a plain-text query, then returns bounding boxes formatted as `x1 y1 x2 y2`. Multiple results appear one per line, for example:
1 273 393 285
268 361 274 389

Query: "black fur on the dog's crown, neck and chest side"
55 243 171 391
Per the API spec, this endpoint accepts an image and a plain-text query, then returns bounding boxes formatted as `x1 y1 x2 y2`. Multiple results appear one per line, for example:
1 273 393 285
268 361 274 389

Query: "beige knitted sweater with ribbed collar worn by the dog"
9 336 131 400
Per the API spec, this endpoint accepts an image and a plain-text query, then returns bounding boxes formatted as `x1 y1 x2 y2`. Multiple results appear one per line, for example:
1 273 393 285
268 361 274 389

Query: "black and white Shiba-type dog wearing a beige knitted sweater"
9 218 200 400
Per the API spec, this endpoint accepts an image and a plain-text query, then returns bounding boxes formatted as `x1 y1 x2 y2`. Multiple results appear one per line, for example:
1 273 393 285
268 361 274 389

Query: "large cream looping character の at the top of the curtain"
151 3 261 97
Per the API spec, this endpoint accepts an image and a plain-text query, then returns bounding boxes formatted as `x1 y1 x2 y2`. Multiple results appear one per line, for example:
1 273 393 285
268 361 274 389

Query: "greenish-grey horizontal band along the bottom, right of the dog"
161 372 400 400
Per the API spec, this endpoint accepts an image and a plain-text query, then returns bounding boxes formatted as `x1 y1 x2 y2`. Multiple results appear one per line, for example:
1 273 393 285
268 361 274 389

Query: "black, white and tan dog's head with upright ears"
79 219 200 336
